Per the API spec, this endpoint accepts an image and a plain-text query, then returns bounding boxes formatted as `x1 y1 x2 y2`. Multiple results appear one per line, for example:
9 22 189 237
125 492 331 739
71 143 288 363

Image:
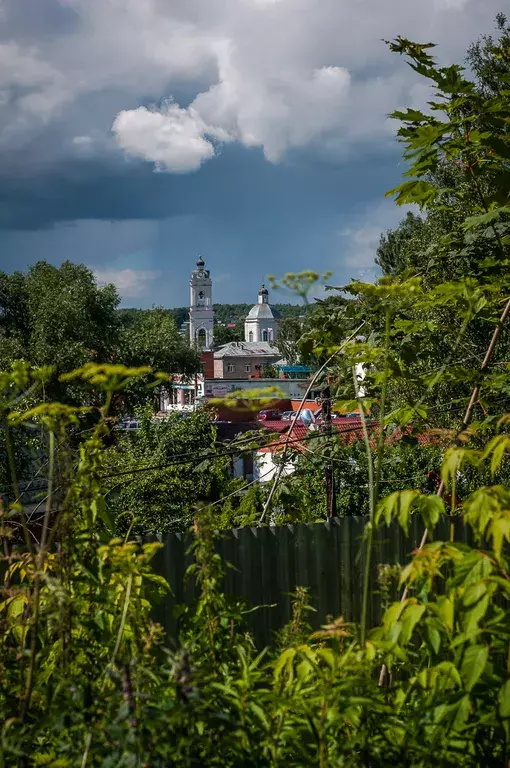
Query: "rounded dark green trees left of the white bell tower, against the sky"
0 261 200 409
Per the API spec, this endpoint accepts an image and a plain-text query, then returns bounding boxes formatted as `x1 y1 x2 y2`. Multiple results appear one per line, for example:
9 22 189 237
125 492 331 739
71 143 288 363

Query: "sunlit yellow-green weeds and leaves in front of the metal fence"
0 367 510 768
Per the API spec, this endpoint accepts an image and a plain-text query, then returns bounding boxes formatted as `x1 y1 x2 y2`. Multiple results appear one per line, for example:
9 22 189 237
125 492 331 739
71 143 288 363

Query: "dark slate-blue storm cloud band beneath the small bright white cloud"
0 136 400 230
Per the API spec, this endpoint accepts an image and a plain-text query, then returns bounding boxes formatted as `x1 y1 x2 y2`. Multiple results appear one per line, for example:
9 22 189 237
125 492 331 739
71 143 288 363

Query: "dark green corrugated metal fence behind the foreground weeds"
155 516 466 644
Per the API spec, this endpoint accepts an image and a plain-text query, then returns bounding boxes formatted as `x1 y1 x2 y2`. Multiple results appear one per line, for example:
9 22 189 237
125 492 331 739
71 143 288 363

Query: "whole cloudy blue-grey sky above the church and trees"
0 0 503 307
